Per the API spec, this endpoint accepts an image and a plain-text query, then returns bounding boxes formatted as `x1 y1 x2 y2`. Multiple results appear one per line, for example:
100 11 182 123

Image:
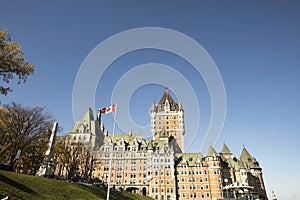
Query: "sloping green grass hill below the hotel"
0 171 151 200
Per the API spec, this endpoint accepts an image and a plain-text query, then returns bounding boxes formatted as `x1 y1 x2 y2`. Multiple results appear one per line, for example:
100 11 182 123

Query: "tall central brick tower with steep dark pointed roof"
151 88 185 152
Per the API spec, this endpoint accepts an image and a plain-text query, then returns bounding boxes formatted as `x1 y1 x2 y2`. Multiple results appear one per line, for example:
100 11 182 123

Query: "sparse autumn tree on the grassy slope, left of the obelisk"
0 102 54 166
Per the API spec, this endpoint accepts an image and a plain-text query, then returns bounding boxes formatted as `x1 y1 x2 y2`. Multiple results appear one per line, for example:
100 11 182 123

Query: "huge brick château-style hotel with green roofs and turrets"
56 89 267 200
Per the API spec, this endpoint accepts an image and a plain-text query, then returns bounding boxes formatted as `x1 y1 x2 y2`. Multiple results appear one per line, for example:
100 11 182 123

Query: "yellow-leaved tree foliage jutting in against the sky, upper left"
0 29 34 95
